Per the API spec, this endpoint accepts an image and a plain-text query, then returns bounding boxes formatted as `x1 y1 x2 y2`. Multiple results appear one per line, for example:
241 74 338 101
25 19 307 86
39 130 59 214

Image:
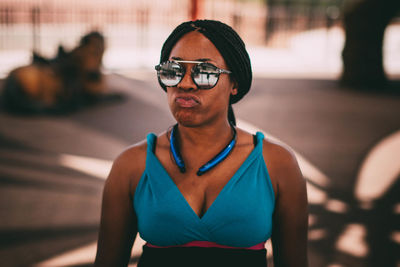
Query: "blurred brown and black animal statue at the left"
2 32 105 114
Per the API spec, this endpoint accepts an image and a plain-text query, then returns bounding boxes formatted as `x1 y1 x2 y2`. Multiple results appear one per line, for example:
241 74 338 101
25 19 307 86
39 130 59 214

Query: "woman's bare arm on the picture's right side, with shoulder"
267 141 308 267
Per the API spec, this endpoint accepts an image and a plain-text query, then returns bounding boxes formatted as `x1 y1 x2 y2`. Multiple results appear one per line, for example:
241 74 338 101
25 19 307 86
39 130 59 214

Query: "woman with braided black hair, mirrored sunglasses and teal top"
96 20 307 267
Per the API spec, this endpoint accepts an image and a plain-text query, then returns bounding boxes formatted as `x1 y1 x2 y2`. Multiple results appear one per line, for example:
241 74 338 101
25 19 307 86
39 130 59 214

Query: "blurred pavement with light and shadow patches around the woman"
0 69 400 267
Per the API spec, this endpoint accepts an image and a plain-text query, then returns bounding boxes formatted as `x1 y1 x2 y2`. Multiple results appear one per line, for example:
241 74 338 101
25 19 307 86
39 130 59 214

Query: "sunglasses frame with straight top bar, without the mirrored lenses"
155 60 232 90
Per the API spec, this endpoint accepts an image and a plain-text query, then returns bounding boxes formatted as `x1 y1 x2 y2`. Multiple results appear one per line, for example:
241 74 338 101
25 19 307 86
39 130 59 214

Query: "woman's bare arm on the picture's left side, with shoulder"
95 148 144 267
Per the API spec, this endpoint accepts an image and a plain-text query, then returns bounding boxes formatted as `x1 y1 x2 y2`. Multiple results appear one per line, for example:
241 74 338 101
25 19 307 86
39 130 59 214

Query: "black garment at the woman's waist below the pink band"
138 245 267 267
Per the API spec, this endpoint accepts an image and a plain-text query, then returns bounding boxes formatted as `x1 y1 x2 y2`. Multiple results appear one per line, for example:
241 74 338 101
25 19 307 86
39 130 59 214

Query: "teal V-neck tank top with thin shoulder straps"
133 132 275 248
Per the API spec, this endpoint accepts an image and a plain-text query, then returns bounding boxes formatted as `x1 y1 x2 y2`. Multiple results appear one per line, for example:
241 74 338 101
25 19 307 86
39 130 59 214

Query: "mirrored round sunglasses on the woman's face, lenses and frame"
155 60 231 89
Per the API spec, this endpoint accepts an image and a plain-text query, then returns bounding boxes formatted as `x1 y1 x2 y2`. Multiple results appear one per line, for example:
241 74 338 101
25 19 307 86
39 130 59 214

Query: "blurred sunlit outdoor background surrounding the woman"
0 0 400 267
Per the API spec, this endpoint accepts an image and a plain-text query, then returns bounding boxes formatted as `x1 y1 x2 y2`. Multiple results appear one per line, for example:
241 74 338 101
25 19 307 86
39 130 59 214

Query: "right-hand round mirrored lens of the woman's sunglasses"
192 63 219 89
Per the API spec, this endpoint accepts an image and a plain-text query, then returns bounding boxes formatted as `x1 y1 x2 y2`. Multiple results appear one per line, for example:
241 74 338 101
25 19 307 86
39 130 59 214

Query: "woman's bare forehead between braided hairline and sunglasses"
169 31 225 66
